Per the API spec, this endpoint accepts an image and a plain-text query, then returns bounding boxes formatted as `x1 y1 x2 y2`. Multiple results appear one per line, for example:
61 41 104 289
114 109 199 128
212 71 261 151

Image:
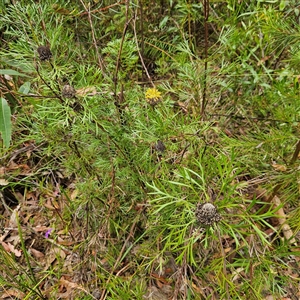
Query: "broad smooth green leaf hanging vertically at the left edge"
0 98 11 148
